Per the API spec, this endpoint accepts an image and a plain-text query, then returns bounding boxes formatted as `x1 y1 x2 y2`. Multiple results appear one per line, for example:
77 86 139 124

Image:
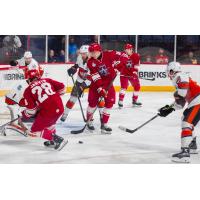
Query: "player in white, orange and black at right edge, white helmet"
159 62 200 162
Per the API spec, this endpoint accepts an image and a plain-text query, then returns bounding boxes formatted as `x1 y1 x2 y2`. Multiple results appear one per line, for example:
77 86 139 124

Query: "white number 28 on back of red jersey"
32 83 55 103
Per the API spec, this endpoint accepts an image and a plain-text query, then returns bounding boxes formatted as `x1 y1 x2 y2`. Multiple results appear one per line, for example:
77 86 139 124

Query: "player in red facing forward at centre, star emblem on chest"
87 43 121 133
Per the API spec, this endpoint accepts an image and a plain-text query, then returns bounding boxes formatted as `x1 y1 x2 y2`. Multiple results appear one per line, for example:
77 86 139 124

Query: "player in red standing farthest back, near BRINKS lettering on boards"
118 44 142 108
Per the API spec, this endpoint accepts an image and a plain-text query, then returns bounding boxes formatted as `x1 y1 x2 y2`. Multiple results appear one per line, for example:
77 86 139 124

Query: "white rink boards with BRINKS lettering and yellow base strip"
0 63 200 96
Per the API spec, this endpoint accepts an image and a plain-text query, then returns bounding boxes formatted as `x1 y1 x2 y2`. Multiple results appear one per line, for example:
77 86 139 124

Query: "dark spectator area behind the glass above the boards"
0 35 200 64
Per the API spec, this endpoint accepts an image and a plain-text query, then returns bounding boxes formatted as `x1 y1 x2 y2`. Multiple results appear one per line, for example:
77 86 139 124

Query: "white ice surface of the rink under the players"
0 92 200 164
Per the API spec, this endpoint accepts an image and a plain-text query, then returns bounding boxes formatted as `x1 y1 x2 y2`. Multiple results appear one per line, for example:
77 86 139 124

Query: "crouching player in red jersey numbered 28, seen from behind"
21 69 66 149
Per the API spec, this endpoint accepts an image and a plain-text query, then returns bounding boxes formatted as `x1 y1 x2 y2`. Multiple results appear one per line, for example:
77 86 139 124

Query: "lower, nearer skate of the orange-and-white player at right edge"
172 148 190 163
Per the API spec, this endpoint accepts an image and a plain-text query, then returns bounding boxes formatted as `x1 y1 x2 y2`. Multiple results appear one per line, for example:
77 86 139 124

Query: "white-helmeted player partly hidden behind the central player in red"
61 45 91 122
